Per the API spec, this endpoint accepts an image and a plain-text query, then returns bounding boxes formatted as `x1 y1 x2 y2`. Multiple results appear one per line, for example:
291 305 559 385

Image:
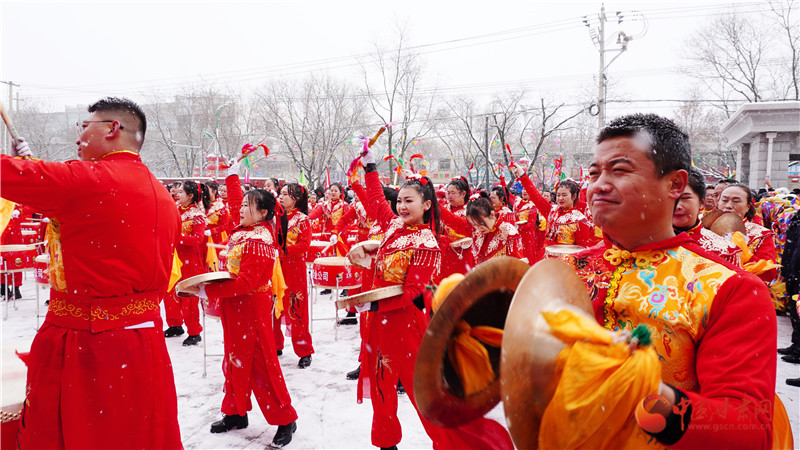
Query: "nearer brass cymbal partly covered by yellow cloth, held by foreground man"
500 259 594 449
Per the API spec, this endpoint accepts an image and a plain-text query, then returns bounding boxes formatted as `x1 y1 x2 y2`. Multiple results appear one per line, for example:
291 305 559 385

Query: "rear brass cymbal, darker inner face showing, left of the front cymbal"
414 257 530 427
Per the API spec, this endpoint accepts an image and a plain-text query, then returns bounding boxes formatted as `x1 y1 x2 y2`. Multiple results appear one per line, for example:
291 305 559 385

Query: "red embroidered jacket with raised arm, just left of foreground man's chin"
518 175 600 247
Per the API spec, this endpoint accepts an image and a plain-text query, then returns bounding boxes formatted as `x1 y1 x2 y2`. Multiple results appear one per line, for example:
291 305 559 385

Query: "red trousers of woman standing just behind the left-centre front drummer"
272 258 314 358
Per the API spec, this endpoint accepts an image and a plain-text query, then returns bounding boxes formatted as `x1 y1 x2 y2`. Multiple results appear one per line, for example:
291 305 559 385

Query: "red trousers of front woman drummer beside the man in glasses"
221 294 297 425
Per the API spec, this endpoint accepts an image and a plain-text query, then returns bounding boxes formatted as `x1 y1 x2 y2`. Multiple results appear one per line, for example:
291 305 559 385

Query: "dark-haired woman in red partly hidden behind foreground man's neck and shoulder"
672 167 742 267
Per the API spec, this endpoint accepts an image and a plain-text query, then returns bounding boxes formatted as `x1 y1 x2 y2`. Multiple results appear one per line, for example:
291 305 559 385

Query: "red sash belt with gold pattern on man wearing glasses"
45 289 164 333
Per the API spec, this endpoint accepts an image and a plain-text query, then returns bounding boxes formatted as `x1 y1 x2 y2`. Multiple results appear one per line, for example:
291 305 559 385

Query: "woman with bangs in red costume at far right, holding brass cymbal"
717 183 778 284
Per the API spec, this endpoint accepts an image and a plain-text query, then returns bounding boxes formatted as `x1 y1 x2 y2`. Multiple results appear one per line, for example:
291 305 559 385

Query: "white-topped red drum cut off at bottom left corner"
0 342 30 449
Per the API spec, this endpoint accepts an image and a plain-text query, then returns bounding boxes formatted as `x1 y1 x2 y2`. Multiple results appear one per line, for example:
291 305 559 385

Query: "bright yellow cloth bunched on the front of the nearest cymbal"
539 310 661 449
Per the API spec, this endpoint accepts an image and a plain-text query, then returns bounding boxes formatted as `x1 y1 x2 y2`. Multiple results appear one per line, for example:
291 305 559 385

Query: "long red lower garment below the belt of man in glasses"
19 320 182 448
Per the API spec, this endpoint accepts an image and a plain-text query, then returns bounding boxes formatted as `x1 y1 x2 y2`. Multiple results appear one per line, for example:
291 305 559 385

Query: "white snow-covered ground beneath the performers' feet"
2 273 800 449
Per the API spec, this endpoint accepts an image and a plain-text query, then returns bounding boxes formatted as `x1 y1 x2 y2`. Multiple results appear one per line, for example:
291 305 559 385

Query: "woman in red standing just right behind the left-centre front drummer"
272 183 314 369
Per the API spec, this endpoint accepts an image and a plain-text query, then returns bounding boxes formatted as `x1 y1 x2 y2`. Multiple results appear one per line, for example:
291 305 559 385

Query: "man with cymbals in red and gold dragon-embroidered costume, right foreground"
575 114 780 448
